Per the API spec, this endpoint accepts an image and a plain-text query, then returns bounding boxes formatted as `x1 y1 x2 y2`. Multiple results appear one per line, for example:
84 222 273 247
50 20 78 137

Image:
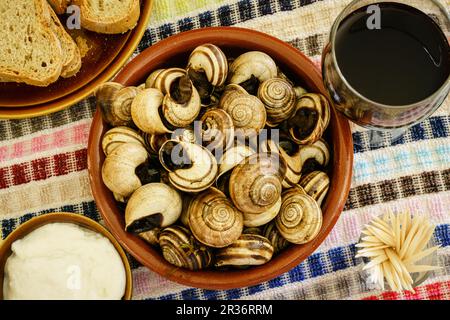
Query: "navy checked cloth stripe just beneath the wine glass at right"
353 116 450 153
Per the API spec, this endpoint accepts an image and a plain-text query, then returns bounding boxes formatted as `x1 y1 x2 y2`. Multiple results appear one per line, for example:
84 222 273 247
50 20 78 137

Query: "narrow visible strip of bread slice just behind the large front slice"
48 2 81 78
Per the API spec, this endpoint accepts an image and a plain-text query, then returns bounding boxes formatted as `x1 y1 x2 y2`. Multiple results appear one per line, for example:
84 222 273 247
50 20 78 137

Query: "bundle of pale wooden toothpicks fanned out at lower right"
356 212 439 291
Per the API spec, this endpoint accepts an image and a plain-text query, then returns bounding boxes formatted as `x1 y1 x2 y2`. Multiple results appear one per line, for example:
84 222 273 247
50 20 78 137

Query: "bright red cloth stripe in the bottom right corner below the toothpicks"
363 281 450 300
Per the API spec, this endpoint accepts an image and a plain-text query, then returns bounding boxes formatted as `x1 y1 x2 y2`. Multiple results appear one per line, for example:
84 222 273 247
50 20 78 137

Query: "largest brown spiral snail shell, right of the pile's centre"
229 153 286 214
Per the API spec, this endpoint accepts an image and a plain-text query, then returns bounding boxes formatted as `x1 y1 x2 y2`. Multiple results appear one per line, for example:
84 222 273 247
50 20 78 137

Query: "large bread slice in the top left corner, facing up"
0 0 64 86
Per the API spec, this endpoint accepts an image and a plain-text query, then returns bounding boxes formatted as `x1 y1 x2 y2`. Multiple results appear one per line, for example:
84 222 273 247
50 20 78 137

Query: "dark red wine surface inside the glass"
335 2 450 106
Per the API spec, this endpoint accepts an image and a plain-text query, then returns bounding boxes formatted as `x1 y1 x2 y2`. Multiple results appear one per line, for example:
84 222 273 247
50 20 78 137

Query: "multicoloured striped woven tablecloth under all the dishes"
0 0 450 299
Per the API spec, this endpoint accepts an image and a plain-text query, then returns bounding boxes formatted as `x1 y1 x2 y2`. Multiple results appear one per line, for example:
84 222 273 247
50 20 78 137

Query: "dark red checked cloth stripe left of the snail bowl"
0 149 87 189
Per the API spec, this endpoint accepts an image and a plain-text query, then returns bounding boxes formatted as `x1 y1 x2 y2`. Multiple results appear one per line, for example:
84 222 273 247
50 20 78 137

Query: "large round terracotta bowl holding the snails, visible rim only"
88 27 353 289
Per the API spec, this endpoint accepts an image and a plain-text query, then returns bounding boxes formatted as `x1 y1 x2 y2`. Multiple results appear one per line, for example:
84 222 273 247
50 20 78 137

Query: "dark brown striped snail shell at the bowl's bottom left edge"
159 226 212 270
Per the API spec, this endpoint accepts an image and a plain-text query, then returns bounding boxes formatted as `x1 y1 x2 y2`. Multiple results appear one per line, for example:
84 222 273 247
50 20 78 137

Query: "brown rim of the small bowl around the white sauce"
0 212 133 300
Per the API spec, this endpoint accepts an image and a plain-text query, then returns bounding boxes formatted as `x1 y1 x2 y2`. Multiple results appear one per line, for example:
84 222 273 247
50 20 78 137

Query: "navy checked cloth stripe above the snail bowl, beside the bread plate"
137 0 323 53
